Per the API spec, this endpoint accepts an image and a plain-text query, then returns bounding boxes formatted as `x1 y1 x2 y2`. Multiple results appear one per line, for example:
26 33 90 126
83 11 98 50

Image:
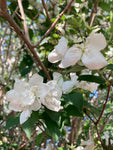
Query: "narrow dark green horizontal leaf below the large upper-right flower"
78 75 105 84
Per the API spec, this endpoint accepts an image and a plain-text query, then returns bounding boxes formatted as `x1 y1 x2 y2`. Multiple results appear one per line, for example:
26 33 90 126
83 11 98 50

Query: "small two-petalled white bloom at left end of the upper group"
48 37 68 63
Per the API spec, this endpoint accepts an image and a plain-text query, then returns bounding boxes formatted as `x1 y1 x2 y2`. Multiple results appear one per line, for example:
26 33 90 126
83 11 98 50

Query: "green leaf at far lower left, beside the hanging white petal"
5 115 19 129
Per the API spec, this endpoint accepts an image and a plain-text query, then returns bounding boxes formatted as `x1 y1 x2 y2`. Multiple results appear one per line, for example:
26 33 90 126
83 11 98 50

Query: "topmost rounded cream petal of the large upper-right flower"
86 32 107 51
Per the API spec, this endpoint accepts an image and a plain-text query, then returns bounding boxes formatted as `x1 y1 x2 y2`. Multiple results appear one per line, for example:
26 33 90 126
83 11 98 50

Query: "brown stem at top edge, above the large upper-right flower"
88 0 99 26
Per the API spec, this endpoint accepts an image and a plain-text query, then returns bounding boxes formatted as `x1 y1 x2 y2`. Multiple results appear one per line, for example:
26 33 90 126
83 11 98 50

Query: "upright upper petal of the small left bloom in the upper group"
55 37 68 56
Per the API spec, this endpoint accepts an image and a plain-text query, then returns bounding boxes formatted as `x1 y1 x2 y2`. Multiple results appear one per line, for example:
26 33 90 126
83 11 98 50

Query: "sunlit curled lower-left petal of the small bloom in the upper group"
48 49 62 63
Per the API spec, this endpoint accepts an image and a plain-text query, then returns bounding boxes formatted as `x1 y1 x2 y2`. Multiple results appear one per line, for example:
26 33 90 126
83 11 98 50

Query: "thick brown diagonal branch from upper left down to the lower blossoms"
3 12 51 80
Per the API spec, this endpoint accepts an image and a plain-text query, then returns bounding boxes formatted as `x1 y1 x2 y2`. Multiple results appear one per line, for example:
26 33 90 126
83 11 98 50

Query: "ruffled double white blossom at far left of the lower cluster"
6 80 35 111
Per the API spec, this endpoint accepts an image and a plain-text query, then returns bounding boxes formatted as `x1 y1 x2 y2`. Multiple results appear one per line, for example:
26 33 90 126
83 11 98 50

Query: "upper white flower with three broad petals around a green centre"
59 31 107 70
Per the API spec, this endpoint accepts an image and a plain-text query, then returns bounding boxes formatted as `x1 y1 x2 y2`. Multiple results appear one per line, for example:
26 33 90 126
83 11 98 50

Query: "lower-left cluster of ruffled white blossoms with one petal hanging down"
6 74 62 124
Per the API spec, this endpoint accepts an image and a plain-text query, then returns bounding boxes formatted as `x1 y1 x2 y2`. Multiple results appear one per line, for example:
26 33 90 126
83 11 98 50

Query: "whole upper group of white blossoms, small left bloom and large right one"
48 31 107 70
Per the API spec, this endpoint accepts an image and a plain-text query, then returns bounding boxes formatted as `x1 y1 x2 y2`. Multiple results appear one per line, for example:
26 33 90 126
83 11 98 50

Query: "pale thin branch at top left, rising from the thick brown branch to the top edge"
18 0 30 42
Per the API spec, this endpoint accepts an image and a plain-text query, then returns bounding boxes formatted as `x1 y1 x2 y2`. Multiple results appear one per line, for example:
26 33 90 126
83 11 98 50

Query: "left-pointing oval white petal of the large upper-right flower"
59 46 82 68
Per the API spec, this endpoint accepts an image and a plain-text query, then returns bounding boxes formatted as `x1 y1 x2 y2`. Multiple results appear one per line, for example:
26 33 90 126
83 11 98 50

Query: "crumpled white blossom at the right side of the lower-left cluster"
41 80 62 111
